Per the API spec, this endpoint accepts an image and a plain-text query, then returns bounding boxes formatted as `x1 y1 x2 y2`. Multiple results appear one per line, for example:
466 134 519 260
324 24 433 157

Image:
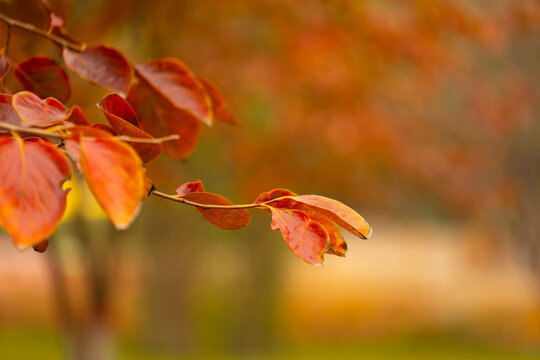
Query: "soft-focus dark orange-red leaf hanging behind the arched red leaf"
127 79 201 160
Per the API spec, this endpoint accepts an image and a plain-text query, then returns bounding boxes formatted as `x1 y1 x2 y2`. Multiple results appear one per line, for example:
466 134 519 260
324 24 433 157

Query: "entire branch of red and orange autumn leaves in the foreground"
0 1 371 264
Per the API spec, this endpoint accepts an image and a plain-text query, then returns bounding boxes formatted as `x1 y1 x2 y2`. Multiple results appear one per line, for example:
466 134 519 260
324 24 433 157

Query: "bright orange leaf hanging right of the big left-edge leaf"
66 127 146 229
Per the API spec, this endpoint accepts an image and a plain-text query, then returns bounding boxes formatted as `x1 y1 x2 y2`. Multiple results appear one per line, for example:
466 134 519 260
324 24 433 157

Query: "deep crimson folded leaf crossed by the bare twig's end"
98 94 163 163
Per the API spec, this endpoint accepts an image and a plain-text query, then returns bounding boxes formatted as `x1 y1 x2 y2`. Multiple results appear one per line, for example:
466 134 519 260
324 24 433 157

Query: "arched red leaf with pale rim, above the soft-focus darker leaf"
135 58 212 125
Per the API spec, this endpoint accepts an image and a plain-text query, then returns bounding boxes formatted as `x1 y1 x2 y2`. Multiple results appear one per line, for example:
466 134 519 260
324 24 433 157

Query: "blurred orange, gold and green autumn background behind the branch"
0 0 540 359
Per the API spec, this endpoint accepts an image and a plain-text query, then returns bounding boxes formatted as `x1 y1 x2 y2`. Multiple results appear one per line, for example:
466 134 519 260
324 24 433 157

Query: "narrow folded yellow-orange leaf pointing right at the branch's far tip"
290 195 371 239
